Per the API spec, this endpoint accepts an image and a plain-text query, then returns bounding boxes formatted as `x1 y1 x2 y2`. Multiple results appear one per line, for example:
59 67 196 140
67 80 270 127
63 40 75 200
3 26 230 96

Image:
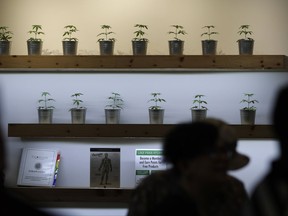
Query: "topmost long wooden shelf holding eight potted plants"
0 55 288 73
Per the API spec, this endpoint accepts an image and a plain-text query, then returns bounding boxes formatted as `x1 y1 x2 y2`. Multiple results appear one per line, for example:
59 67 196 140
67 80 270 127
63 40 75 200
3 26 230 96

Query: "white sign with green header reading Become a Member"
135 149 166 185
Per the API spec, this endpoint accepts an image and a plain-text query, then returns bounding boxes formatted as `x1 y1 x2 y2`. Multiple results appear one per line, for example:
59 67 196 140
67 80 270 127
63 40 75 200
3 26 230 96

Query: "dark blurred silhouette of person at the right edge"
243 85 288 216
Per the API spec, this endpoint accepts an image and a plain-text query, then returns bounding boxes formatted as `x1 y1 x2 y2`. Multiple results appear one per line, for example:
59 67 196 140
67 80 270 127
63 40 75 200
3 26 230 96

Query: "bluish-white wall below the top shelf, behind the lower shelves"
0 71 288 215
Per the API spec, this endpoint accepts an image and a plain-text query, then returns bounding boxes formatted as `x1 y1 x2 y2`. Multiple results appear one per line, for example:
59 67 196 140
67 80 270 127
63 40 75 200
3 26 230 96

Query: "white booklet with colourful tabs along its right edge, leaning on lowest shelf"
17 148 60 187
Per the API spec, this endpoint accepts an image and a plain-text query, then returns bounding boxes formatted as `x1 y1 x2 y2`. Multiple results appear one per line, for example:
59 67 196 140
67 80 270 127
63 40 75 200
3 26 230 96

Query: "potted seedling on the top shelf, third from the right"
168 25 187 55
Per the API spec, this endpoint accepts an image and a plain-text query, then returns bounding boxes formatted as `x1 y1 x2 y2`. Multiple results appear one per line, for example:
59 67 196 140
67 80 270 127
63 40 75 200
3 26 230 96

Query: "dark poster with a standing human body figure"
90 148 120 188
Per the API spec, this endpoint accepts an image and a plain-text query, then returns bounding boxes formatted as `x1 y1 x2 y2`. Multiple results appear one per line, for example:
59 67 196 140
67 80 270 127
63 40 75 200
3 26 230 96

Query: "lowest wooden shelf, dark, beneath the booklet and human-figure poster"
7 187 133 204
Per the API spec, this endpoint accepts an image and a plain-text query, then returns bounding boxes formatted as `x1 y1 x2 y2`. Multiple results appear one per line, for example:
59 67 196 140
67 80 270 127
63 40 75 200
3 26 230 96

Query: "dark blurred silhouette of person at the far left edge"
0 129 52 216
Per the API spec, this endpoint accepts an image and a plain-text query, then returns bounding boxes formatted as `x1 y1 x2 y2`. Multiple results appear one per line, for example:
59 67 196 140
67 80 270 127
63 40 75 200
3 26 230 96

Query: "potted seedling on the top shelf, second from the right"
201 25 218 55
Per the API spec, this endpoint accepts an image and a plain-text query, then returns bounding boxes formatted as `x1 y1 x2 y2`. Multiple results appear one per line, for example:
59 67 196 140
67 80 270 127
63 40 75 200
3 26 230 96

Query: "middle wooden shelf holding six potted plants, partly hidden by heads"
8 123 274 139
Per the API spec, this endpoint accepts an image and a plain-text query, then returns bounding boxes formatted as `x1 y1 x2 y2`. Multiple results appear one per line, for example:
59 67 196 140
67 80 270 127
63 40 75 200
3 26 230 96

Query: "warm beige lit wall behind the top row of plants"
0 0 288 55
